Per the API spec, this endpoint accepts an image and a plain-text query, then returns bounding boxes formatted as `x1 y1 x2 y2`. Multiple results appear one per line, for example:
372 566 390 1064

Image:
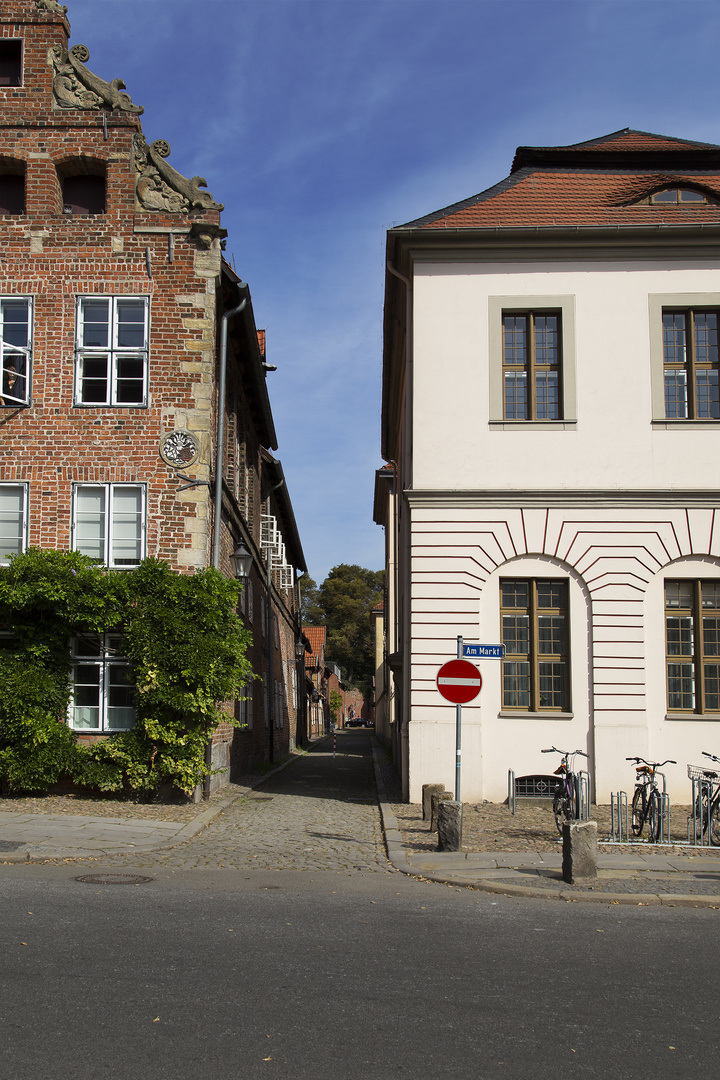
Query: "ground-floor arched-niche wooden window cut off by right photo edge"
665 581 720 714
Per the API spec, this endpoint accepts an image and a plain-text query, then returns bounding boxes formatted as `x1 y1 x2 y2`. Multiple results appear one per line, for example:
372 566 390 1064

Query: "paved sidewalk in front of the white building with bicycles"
373 745 720 909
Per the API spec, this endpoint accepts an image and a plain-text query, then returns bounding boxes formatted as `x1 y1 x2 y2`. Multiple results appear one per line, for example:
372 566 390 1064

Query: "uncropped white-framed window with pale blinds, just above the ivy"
72 484 146 567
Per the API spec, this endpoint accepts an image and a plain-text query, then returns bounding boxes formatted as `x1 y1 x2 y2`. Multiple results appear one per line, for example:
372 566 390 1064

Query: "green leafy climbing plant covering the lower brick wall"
0 549 253 795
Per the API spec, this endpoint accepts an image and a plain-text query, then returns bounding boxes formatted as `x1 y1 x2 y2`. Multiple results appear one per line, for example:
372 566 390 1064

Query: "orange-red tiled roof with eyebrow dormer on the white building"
410 130 720 229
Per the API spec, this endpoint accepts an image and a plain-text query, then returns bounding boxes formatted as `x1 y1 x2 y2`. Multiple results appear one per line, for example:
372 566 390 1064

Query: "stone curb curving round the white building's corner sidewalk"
372 737 720 909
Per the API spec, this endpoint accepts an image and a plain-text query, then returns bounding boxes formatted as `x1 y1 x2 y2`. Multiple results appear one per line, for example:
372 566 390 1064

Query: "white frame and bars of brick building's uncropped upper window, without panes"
74 294 150 408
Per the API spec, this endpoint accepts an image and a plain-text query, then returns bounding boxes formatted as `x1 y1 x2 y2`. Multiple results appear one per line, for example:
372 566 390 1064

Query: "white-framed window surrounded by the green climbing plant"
70 634 136 732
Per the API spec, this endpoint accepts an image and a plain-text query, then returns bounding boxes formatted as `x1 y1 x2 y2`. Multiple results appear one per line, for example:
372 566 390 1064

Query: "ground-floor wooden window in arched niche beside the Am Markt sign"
500 578 570 713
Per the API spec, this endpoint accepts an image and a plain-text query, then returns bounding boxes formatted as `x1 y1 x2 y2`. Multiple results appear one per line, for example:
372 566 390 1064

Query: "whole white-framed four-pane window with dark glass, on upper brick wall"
74 296 149 406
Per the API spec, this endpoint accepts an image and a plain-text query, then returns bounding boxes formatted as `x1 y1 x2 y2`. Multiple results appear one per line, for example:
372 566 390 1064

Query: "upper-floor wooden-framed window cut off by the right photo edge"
663 308 720 420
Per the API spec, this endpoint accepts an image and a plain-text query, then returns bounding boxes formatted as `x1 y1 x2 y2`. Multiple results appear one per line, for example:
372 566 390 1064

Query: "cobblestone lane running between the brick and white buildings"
94 731 391 873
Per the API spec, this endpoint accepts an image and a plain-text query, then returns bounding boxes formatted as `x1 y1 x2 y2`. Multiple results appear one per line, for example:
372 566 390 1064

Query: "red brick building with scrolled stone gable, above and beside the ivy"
0 0 305 790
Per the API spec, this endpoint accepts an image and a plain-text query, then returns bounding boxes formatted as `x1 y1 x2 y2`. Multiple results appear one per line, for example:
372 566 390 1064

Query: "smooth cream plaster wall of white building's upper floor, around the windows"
412 259 720 490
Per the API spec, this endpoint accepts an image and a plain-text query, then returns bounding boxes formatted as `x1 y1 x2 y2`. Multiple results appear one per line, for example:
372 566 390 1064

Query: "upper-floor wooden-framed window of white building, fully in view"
503 311 562 420
